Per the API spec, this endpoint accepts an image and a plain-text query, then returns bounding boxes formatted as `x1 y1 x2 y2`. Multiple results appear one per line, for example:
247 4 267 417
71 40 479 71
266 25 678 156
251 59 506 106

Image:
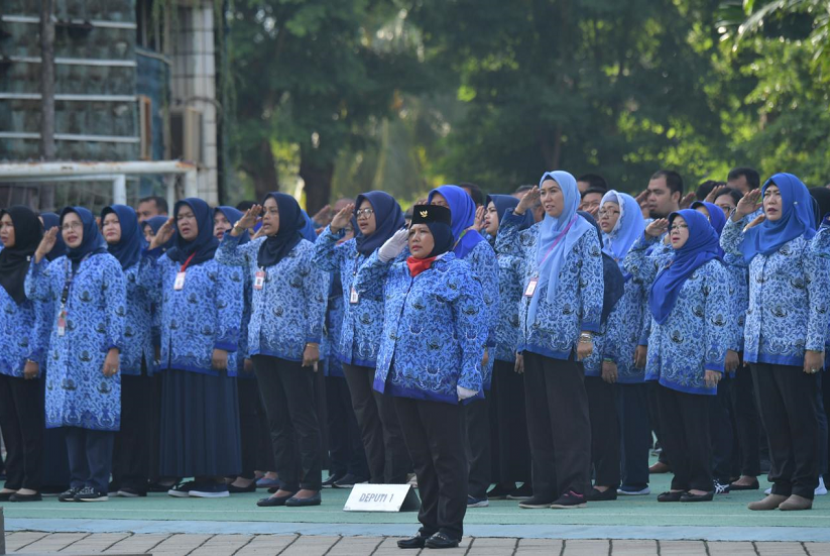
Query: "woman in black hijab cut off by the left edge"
0 206 46 502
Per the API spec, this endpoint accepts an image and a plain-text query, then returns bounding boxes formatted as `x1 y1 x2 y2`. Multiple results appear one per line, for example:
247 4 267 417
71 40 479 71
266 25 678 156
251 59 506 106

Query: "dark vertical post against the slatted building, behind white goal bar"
40 0 55 210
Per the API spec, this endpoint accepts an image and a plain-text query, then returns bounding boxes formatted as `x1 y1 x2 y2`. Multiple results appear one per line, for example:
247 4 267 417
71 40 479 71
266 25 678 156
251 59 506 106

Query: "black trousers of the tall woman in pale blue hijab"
524 352 591 500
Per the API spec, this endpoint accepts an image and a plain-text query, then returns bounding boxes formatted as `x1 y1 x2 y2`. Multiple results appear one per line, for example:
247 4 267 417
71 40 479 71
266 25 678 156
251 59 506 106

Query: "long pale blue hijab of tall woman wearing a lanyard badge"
528 170 593 322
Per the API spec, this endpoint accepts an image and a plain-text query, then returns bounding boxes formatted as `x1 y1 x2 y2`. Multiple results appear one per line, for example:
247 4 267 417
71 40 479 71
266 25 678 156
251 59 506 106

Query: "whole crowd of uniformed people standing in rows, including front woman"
0 164 830 548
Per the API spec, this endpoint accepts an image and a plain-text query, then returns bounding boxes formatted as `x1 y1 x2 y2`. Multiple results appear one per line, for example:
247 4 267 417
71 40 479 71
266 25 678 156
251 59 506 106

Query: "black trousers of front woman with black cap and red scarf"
394 398 467 540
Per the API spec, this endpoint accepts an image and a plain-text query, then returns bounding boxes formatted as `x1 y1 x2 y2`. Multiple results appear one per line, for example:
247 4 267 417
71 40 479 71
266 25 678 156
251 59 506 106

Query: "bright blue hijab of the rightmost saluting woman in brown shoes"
741 174 816 263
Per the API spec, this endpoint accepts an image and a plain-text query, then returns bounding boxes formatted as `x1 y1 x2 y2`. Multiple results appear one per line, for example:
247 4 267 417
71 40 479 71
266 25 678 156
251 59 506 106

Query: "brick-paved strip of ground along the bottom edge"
6 532 830 556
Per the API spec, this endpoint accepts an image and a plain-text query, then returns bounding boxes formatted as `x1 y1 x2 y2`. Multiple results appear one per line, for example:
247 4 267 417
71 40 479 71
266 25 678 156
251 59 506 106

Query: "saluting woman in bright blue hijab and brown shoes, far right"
721 173 830 510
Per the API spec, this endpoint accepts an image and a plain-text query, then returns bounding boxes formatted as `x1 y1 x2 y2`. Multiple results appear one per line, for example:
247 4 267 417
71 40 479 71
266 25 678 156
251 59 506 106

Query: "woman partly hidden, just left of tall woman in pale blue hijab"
484 195 534 500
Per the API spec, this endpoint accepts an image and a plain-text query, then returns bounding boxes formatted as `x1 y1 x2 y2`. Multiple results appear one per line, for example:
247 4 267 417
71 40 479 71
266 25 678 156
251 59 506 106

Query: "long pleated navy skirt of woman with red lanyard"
159 369 242 477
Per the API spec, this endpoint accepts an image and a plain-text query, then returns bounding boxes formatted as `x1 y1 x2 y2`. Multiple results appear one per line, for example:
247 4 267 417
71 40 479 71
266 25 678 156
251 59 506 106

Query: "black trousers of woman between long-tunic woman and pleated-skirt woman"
112 374 152 490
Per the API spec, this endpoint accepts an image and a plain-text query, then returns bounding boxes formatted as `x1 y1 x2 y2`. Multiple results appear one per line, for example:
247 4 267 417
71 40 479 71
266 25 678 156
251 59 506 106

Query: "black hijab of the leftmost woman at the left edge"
0 205 43 305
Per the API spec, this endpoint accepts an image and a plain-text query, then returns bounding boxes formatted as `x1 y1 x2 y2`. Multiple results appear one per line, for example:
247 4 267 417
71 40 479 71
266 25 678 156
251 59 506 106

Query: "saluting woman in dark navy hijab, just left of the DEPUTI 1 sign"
217 193 328 507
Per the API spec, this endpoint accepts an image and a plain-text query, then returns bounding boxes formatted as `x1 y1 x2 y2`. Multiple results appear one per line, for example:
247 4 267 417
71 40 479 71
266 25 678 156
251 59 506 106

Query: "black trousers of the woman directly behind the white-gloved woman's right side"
462 392 492 499
